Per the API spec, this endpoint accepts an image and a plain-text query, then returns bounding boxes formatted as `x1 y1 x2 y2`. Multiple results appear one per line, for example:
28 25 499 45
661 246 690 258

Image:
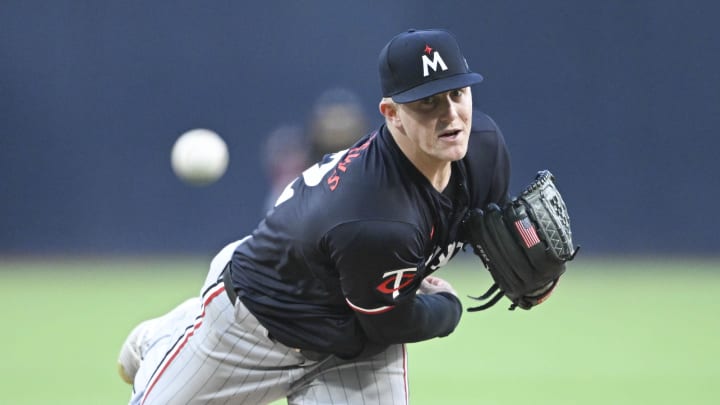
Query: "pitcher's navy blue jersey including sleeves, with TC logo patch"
231 112 510 357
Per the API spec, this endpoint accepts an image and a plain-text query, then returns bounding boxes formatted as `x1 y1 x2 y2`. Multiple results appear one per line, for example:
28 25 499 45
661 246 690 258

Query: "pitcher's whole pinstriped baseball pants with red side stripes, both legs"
130 240 408 405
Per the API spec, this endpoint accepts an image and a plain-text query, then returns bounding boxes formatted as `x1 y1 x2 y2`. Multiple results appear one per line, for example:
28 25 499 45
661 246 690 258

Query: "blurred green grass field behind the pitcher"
0 257 720 405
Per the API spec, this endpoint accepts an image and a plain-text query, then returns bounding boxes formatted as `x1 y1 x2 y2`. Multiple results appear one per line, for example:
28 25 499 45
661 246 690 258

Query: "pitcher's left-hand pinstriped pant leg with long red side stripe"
131 237 307 405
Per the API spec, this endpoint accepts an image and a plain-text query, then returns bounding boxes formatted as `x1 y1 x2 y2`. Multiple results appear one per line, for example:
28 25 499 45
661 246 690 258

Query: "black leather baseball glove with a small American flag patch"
464 170 579 312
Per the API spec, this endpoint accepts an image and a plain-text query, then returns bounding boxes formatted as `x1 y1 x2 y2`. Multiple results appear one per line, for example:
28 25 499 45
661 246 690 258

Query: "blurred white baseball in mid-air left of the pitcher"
170 128 229 186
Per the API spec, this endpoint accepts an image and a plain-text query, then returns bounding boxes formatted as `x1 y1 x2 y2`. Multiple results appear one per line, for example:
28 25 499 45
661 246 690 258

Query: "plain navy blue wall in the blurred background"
0 0 720 254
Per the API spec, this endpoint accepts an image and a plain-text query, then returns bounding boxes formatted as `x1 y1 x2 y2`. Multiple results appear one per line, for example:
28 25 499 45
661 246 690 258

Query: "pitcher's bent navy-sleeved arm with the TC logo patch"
328 220 462 344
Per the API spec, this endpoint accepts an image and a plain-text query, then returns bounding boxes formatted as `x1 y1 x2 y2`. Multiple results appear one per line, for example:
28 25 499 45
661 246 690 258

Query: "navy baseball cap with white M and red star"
378 29 483 103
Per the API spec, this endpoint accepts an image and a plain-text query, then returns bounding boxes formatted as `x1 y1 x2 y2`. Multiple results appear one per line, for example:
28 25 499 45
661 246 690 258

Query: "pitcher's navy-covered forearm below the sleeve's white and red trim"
360 293 462 344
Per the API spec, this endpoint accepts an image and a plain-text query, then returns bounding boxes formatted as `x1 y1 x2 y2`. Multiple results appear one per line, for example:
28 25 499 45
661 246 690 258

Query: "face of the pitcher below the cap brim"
398 87 472 163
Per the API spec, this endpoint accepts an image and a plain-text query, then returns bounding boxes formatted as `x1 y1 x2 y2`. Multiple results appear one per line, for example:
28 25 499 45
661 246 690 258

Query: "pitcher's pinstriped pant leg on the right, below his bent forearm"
288 345 408 405
